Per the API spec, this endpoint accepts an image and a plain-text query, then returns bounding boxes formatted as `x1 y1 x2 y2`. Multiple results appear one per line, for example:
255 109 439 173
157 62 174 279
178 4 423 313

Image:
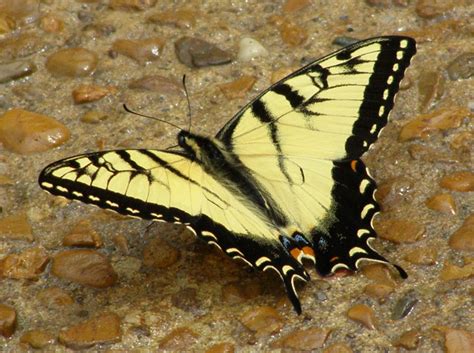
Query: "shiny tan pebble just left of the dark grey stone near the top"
112 38 165 65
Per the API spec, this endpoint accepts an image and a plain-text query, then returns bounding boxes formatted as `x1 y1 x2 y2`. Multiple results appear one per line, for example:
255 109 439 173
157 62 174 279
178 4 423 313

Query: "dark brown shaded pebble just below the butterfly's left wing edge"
143 238 181 268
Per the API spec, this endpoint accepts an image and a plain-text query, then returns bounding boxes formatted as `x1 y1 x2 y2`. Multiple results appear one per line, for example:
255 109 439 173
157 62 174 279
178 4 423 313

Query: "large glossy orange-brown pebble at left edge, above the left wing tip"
0 108 71 154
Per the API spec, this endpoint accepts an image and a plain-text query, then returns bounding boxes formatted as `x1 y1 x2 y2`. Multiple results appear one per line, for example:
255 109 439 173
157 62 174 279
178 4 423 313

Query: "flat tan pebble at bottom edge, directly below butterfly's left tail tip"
272 327 331 351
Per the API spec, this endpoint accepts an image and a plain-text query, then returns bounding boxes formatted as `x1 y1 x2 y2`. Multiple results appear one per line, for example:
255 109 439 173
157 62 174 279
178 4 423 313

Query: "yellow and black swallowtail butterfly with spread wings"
39 36 416 313
